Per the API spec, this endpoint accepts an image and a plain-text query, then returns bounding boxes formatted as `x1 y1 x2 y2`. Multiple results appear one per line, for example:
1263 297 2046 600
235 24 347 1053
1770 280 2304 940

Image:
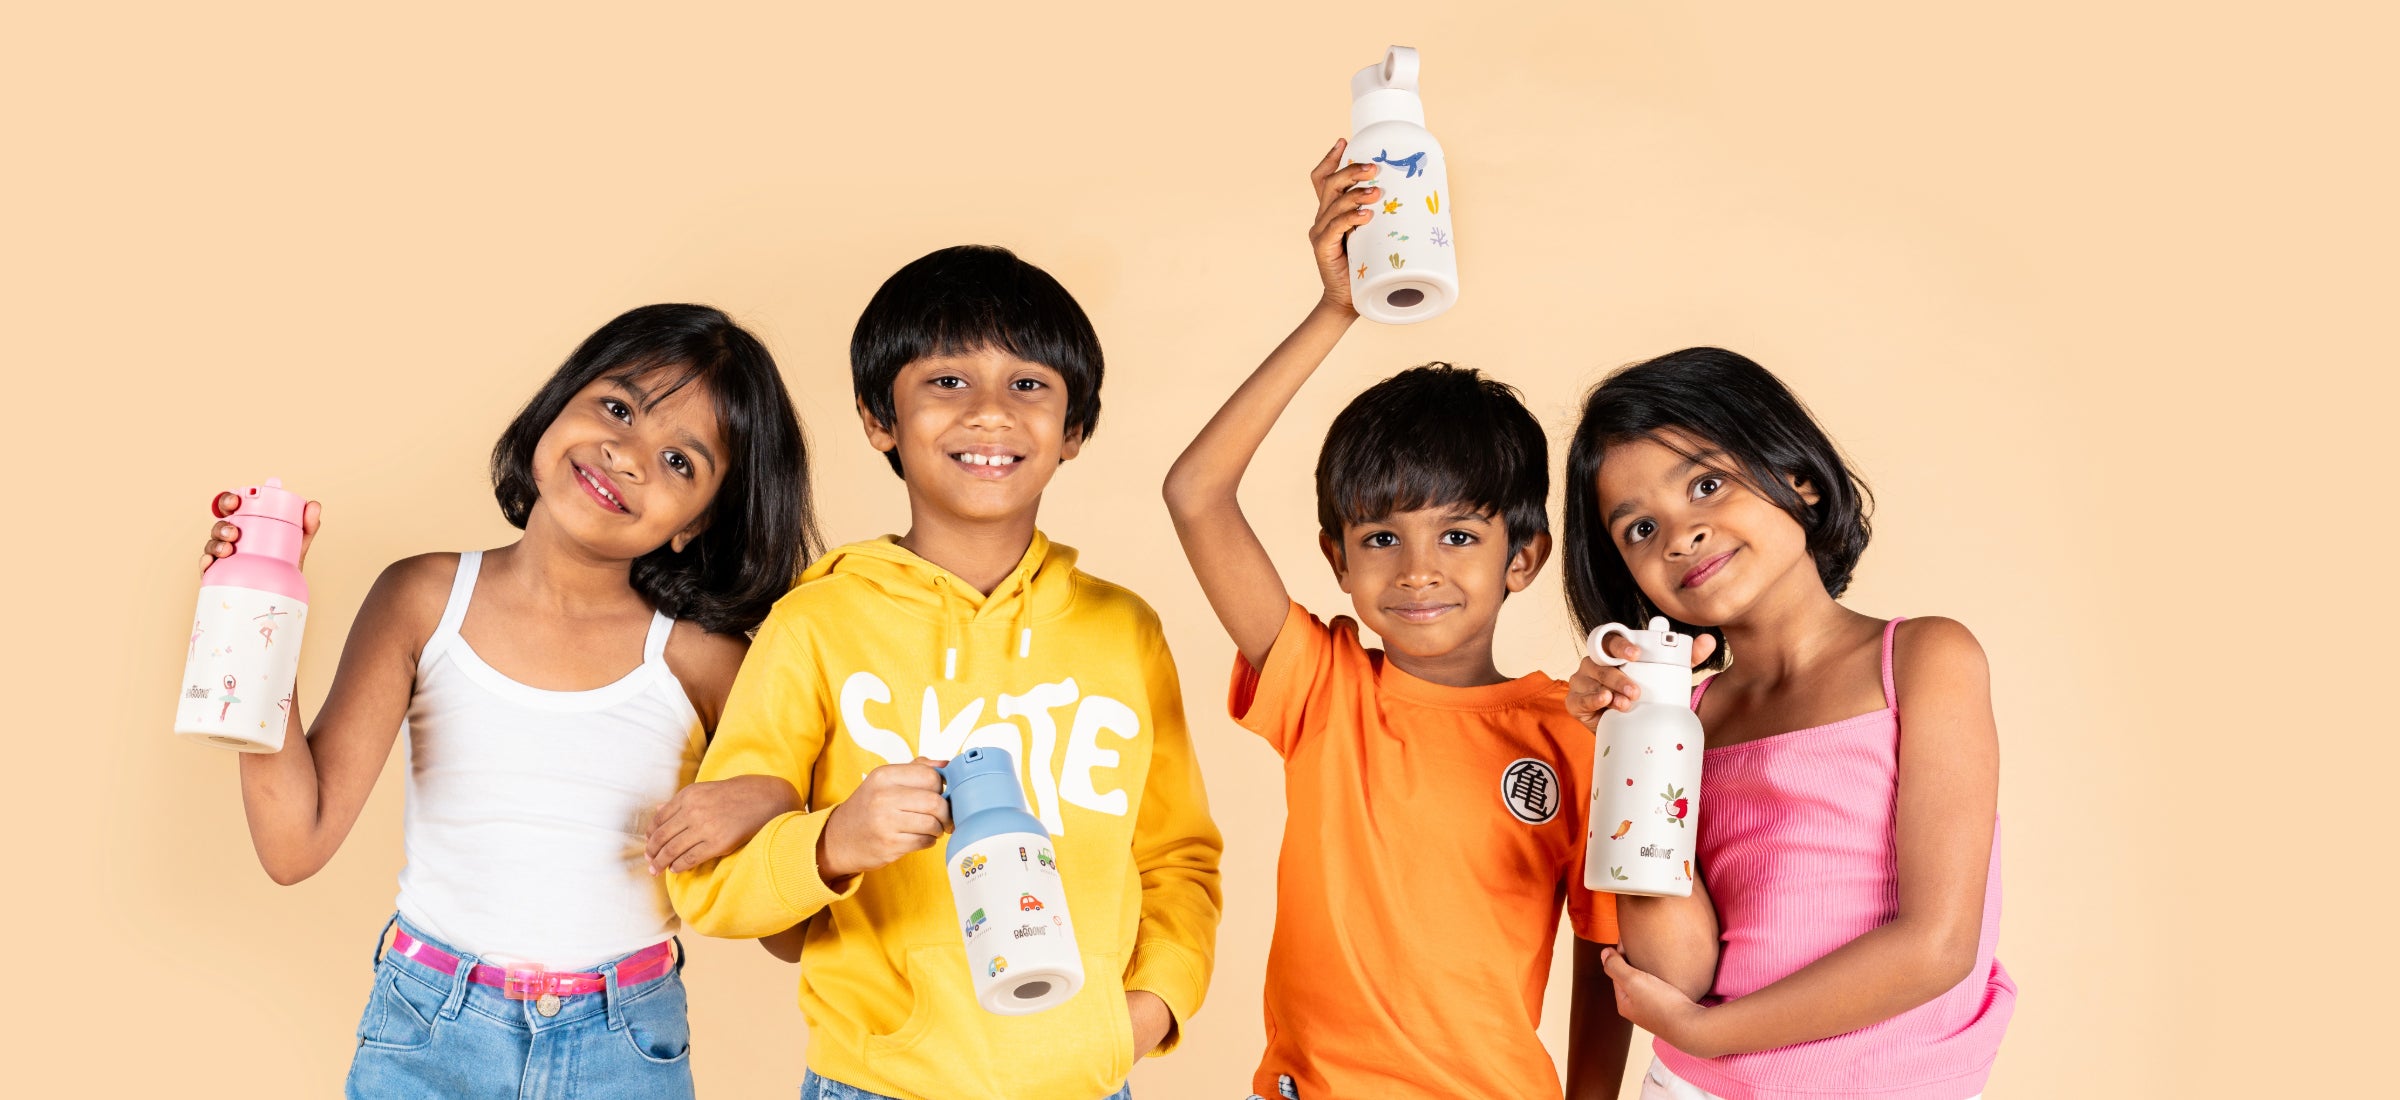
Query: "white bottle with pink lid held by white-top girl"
175 478 307 752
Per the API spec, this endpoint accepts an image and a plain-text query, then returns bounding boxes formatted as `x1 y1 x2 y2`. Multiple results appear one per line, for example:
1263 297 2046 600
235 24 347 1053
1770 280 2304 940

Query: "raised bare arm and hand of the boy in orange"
1166 142 1378 668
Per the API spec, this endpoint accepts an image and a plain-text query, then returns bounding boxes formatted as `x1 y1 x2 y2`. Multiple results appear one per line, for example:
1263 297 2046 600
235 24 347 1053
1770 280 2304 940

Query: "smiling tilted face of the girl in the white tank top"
528 370 730 560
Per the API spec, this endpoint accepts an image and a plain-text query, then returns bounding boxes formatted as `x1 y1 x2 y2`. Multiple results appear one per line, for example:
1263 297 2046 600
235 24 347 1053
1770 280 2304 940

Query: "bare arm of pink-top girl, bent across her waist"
1608 620 1999 1057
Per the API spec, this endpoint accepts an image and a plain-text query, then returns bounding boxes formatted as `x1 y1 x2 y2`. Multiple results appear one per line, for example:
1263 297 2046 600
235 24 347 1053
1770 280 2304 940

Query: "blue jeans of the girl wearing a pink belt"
343 917 691 1100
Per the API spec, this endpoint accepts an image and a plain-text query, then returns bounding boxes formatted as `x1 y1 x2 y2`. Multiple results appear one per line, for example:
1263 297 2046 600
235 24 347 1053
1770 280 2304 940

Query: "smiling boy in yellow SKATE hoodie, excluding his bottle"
653 245 1222 1100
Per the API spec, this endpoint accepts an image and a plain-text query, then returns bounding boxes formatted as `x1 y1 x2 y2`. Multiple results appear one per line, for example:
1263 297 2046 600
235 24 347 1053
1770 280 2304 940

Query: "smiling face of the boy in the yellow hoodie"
859 348 1082 524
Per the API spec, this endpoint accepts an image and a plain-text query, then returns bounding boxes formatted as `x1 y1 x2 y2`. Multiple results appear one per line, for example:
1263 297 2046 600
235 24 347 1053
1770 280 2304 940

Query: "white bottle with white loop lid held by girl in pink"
1584 620 1706 898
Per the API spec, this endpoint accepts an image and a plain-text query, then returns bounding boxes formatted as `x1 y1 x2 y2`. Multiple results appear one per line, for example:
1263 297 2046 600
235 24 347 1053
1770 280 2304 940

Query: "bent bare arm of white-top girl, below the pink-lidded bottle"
240 555 456 886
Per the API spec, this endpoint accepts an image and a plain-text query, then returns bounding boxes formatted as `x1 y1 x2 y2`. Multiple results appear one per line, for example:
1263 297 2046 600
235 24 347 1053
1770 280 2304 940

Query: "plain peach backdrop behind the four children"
0 0 2400 1098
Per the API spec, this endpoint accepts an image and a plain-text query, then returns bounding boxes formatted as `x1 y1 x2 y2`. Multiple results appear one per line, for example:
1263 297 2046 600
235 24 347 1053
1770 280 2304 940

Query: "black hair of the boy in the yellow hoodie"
850 245 1102 478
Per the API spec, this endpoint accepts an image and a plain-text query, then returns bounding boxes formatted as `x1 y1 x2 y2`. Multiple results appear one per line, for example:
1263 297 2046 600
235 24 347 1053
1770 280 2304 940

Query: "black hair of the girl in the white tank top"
492 305 821 634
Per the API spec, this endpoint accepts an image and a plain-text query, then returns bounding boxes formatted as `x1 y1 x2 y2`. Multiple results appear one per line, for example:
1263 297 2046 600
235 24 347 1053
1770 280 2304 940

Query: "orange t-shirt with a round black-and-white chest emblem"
1229 603 1618 1100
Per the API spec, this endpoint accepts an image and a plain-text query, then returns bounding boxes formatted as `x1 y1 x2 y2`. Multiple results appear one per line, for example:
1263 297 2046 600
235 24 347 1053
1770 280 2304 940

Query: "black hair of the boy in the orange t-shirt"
1318 363 1550 555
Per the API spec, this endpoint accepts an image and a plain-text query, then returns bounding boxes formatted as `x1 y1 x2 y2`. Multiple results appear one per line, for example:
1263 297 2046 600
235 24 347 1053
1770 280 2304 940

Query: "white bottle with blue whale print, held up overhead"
1346 46 1459 324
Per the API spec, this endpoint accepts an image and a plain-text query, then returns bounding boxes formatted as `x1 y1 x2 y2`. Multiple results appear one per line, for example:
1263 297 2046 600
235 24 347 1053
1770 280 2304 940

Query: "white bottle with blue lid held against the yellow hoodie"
941 747 1082 1016
